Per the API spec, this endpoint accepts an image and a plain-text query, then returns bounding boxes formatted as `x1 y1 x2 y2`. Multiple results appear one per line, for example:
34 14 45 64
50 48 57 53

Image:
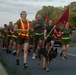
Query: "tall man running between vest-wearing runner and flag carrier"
32 14 44 59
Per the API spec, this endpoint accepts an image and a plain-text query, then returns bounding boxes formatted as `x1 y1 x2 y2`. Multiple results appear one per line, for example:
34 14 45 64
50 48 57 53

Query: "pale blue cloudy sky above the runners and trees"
0 0 76 27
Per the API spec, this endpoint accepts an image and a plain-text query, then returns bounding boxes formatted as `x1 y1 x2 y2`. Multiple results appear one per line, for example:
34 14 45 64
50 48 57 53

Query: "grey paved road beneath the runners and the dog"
0 47 76 75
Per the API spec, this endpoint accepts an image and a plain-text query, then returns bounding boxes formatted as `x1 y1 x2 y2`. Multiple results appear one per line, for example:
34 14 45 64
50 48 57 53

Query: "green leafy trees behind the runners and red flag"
35 2 76 27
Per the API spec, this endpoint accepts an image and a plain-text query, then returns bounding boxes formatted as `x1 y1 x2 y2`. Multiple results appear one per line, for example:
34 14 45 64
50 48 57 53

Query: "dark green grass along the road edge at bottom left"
0 55 31 75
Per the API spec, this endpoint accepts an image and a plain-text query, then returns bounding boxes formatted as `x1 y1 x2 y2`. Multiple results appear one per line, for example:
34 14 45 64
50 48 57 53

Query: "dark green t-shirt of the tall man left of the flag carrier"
32 20 44 34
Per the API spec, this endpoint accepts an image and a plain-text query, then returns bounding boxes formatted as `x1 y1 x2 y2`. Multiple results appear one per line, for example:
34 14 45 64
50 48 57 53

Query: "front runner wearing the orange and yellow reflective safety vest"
14 11 30 68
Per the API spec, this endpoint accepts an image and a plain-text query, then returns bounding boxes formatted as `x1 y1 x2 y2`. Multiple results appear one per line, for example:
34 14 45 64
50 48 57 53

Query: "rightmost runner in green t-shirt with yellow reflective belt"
60 22 72 59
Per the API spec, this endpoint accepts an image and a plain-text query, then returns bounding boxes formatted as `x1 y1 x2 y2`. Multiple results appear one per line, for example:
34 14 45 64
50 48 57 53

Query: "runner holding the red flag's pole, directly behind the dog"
44 19 55 49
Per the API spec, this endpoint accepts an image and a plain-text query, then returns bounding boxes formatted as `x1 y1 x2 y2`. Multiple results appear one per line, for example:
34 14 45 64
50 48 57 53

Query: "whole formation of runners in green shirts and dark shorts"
0 11 73 68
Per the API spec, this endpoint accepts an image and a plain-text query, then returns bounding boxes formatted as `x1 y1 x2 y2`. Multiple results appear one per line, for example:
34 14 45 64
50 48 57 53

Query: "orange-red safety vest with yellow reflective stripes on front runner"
18 19 30 39
